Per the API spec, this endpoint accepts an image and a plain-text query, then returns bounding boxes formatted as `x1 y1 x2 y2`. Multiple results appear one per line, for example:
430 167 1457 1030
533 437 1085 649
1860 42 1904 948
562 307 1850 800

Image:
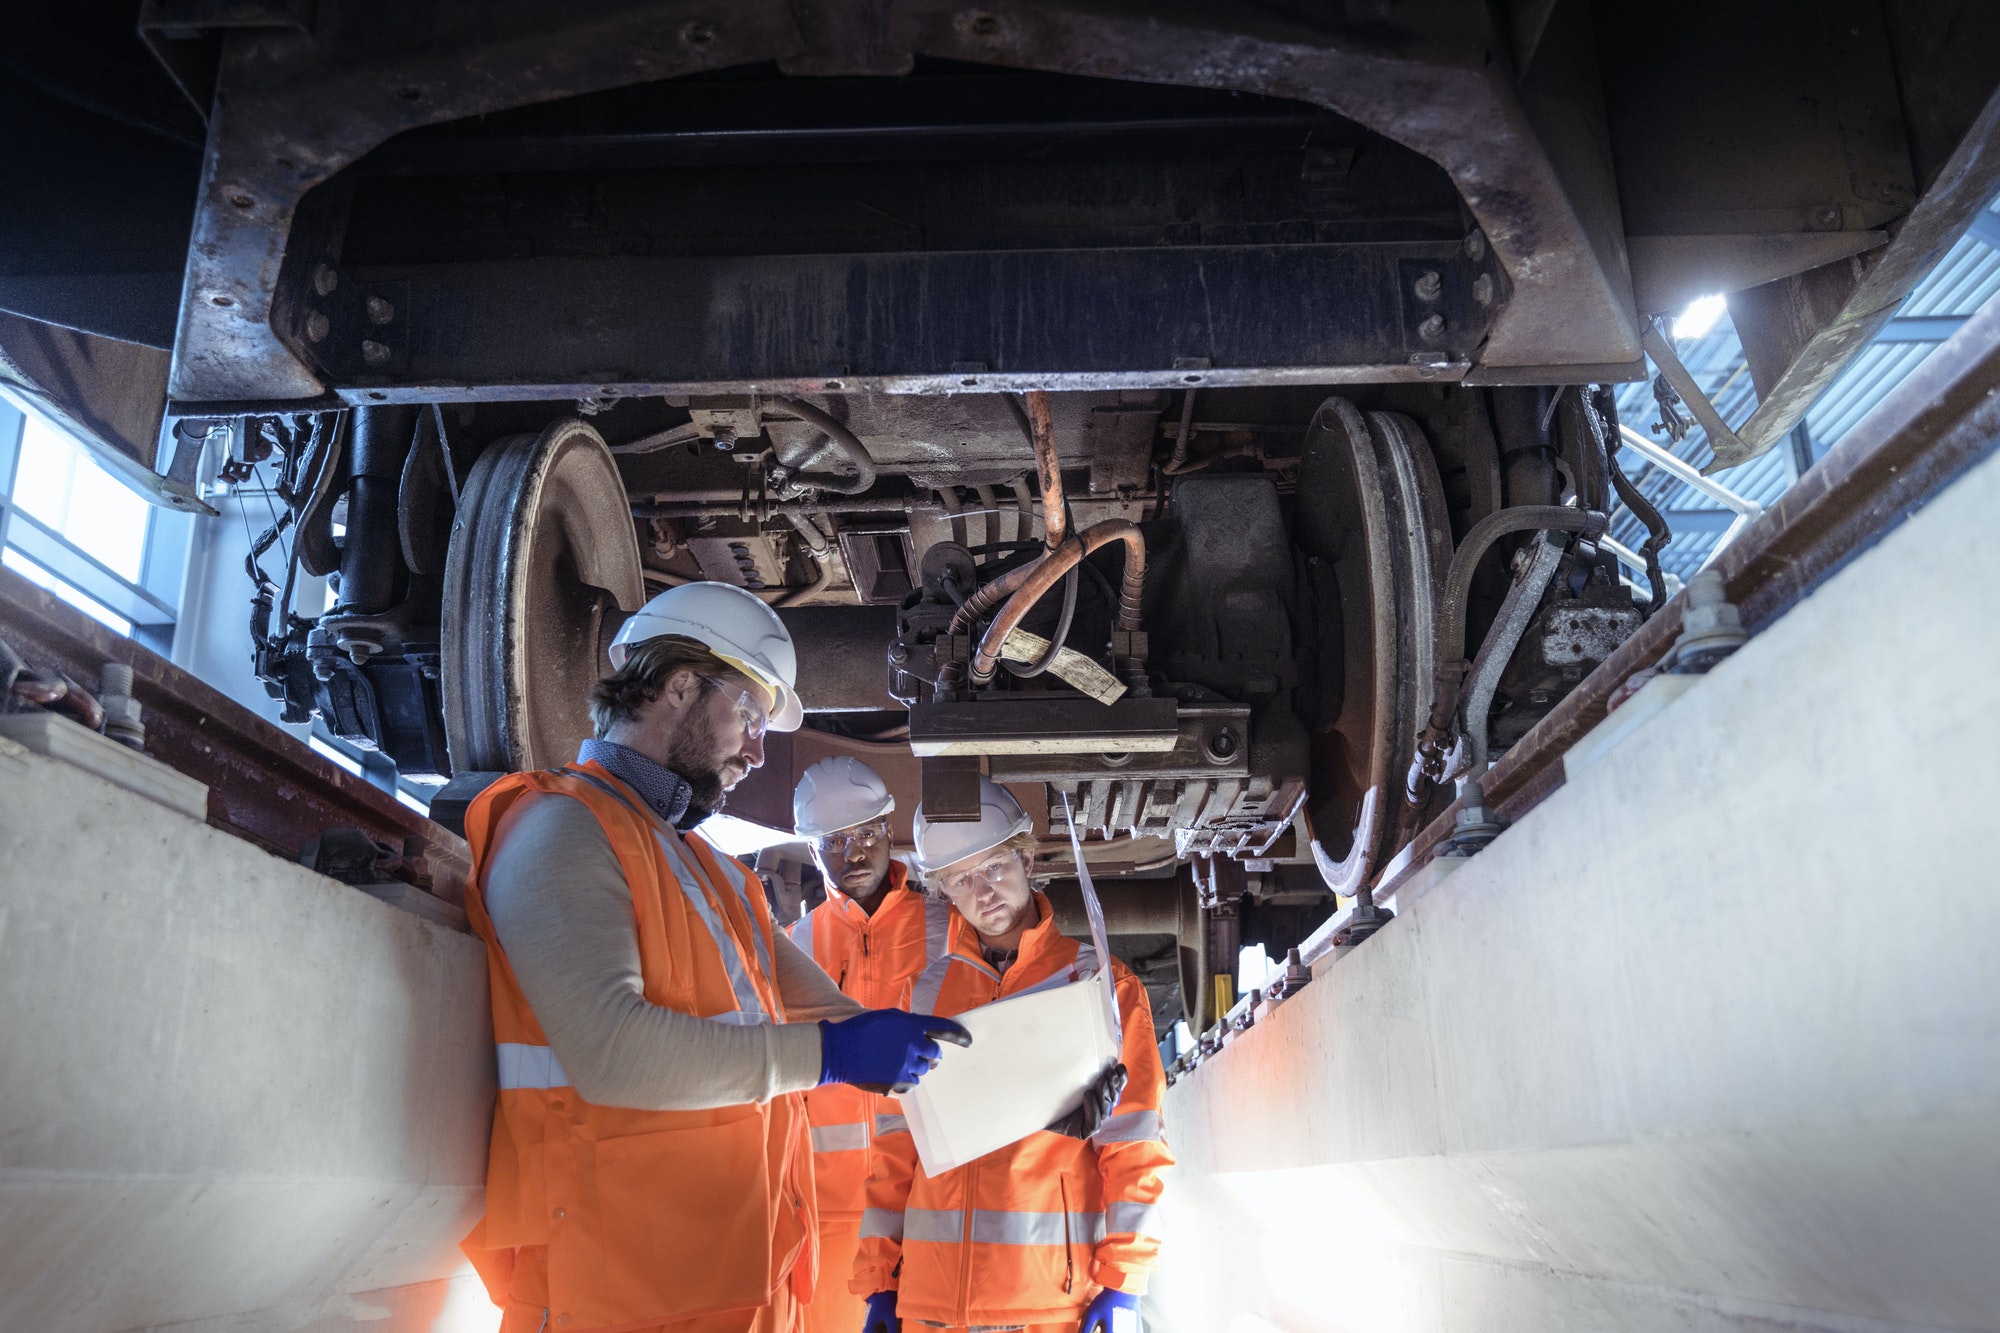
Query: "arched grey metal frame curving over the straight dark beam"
172 0 1638 400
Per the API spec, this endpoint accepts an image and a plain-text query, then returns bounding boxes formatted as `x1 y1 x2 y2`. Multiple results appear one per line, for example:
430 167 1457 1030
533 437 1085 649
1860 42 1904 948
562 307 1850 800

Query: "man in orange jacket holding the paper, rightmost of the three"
852 779 1174 1333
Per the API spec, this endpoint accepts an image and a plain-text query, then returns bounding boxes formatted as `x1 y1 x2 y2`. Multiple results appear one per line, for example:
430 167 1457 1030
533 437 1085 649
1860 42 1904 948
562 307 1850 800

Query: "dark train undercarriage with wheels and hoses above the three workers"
0 0 2000 1031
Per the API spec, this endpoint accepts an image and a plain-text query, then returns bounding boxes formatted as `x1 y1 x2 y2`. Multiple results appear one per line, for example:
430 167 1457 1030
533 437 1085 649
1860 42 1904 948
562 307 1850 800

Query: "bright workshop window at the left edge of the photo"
0 398 190 652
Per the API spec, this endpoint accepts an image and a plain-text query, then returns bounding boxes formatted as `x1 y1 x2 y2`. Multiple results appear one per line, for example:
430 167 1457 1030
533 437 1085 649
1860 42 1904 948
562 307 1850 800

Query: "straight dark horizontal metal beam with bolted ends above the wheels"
316 242 1490 402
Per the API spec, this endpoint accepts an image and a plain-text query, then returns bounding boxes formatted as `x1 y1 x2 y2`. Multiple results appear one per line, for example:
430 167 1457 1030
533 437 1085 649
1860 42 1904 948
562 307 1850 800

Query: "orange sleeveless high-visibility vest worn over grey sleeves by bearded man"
464 763 816 1333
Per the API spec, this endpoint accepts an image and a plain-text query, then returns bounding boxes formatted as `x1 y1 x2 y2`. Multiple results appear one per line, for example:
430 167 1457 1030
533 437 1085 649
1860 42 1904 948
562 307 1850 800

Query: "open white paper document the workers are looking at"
896 971 1120 1175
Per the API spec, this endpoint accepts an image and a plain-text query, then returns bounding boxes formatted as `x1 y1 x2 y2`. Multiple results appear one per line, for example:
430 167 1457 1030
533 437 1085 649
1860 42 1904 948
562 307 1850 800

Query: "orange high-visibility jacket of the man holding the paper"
850 893 1174 1327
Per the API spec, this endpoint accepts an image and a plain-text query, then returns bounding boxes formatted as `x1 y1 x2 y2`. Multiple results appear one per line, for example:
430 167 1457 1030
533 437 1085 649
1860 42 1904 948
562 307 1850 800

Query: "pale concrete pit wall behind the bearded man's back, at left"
0 741 498 1333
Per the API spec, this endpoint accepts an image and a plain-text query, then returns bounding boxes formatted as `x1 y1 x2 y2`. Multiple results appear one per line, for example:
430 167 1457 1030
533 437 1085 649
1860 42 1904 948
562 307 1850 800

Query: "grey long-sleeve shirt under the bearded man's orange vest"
484 795 862 1111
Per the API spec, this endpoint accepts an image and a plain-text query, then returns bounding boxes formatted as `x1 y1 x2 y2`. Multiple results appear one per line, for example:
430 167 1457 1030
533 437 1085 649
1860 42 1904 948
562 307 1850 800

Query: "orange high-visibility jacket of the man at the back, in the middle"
790 861 944 1216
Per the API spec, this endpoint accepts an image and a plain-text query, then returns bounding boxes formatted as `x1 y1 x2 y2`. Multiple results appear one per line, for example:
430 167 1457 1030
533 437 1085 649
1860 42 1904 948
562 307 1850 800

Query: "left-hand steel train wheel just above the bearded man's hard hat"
444 420 646 773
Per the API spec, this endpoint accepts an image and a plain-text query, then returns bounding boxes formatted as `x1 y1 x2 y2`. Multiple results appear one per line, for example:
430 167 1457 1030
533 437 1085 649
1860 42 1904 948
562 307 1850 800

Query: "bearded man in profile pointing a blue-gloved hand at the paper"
466 582 964 1333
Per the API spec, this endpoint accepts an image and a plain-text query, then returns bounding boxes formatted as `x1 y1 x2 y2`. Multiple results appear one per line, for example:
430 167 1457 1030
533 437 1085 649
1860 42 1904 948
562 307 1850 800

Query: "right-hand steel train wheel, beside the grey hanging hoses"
1296 398 1452 895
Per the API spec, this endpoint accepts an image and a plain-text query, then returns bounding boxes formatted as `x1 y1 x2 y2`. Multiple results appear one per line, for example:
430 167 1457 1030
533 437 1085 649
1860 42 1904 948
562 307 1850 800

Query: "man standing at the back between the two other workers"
790 755 942 1333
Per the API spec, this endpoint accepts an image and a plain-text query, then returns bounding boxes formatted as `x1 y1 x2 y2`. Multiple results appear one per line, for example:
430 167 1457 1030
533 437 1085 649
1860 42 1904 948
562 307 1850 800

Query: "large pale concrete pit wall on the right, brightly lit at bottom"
1148 440 2000 1333
